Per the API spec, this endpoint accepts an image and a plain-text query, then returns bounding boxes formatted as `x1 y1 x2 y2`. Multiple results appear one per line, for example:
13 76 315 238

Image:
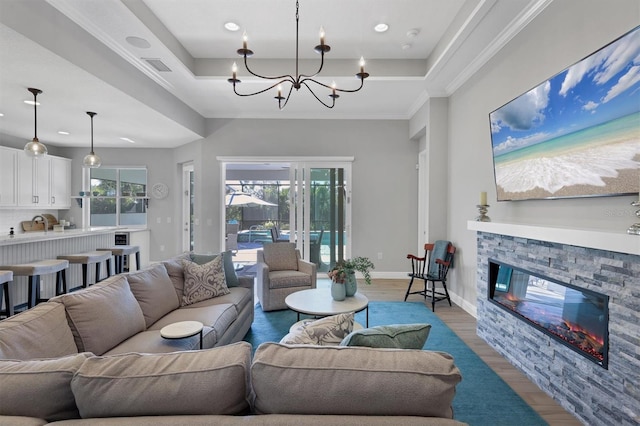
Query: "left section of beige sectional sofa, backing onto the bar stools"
0 254 254 359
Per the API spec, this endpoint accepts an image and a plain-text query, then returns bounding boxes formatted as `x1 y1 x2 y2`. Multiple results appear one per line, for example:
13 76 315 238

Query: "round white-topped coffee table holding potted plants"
284 288 369 327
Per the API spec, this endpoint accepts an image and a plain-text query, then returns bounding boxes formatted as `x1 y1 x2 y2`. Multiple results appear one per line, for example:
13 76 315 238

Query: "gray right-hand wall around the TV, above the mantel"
447 0 640 311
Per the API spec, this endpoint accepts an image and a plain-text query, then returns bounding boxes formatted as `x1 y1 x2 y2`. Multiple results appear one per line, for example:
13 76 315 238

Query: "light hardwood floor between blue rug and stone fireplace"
356 279 581 426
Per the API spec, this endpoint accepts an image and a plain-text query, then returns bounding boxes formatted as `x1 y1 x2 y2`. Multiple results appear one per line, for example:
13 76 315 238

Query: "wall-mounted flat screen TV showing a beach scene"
489 26 640 201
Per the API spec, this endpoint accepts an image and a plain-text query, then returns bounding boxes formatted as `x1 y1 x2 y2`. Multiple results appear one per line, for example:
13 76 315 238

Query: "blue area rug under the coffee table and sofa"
244 302 547 426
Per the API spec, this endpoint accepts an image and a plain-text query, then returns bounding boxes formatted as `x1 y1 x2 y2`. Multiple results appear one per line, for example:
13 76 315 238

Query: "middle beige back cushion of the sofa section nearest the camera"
71 342 251 418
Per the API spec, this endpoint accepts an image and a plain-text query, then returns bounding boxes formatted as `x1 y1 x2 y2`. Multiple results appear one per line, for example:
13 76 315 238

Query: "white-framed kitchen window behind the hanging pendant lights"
89 167 147 226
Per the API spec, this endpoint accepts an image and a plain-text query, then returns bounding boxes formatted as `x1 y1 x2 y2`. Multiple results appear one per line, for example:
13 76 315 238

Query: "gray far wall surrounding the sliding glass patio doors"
196 120 418 272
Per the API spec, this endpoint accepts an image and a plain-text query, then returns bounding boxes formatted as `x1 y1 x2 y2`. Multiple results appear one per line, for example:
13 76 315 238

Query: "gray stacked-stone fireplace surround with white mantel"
467 221 640 426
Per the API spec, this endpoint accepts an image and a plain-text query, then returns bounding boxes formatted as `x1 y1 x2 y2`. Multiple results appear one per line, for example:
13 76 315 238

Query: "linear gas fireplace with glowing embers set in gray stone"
488 259 609 368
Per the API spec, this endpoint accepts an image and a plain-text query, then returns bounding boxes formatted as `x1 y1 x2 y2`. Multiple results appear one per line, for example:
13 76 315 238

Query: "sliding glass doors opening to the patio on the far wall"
219 158 353 272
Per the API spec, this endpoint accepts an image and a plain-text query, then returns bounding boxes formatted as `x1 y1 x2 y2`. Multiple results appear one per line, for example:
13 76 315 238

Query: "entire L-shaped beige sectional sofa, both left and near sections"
0 253 461 426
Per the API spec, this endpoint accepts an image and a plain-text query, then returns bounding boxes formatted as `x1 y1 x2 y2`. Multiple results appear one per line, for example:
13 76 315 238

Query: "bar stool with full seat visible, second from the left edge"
0 259 69 308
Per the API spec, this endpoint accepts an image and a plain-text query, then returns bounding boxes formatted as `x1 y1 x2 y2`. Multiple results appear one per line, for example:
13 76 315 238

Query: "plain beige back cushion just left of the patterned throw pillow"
127 263 180 327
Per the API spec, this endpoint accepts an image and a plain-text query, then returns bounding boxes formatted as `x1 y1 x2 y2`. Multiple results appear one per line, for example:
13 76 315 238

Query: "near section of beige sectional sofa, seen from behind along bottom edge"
0 342 462 426
